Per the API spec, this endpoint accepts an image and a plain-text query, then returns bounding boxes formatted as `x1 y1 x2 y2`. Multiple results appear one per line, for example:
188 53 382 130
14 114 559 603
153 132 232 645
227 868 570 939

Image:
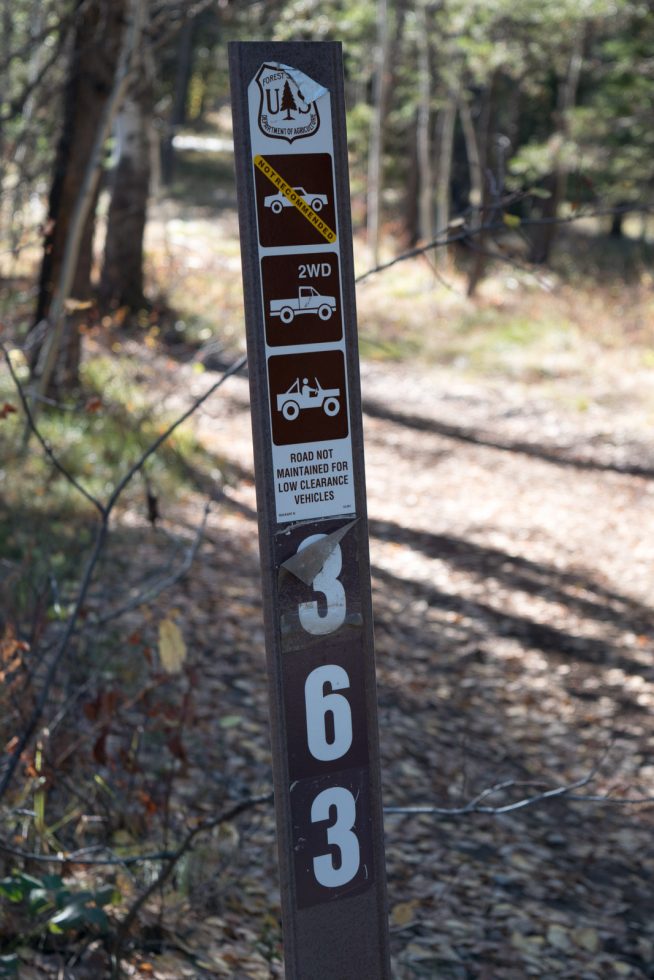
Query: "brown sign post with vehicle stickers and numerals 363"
229 42 390 980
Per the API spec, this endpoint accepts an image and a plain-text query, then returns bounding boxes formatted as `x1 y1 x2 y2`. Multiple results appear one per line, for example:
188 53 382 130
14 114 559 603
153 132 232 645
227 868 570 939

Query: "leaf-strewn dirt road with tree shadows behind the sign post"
156 348 654 980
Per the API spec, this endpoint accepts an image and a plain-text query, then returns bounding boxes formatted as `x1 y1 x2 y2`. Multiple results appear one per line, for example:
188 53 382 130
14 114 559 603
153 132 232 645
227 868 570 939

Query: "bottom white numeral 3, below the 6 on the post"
311 786 360 888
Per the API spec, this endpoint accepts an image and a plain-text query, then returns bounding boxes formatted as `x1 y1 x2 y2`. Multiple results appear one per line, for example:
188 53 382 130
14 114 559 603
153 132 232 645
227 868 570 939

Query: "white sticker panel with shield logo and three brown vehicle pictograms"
248 63 355 523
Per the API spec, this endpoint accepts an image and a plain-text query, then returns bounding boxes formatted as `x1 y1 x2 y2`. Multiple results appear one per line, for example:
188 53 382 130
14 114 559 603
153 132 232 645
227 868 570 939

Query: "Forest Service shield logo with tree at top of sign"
256 65 320 143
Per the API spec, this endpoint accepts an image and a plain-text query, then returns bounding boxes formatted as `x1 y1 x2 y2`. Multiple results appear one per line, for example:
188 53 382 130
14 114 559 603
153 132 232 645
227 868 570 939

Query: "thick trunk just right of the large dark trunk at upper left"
100 35 154 310
